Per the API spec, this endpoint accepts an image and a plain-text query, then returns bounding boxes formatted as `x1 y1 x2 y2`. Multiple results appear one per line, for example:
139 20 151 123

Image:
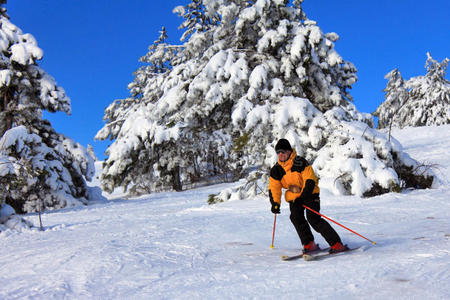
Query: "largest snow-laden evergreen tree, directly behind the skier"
97 0 432 197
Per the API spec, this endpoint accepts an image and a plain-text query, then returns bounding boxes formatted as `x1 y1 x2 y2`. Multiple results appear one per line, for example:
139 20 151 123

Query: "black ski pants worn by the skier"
289 195 341 246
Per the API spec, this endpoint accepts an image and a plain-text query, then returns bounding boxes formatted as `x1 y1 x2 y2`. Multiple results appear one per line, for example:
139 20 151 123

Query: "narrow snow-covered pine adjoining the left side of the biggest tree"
96 27 185 194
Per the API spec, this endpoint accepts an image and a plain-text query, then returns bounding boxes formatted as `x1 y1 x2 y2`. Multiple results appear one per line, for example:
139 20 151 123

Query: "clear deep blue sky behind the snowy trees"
6 0 450 159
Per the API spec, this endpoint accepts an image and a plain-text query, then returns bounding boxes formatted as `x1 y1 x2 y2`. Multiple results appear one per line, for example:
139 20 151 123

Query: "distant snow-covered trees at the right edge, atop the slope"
375 53 450 128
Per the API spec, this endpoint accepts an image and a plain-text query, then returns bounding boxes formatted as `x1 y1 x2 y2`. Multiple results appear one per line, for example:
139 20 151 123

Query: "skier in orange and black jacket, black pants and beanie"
269 139 348 253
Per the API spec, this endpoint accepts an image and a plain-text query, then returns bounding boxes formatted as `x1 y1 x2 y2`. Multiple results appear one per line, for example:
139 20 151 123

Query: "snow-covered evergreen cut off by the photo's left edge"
0 5 94 213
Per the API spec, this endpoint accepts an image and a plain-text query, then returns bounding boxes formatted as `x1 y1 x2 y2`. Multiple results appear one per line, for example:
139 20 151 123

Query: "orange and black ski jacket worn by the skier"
269 150 320 203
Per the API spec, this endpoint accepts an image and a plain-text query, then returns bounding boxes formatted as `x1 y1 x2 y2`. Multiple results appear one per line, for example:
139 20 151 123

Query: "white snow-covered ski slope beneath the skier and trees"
0 125 450 299
